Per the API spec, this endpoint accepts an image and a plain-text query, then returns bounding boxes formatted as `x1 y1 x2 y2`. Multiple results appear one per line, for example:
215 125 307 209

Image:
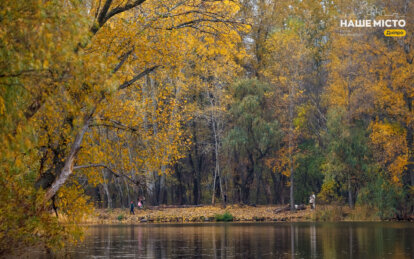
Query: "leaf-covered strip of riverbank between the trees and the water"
80 205 404 224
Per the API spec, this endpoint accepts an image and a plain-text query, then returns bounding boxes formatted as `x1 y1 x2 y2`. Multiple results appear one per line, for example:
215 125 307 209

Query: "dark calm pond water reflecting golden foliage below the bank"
39 222 414 259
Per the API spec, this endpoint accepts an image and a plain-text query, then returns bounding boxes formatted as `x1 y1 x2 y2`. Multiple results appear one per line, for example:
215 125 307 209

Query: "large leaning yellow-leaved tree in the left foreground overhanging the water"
0 0 244 253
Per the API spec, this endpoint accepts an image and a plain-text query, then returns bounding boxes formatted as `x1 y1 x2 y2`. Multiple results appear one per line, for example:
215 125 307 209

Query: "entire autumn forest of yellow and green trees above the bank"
0 0 414 255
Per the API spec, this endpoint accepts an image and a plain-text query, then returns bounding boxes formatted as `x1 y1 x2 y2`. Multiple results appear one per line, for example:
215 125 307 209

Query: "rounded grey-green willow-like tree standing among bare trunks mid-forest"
225 80 282 204
